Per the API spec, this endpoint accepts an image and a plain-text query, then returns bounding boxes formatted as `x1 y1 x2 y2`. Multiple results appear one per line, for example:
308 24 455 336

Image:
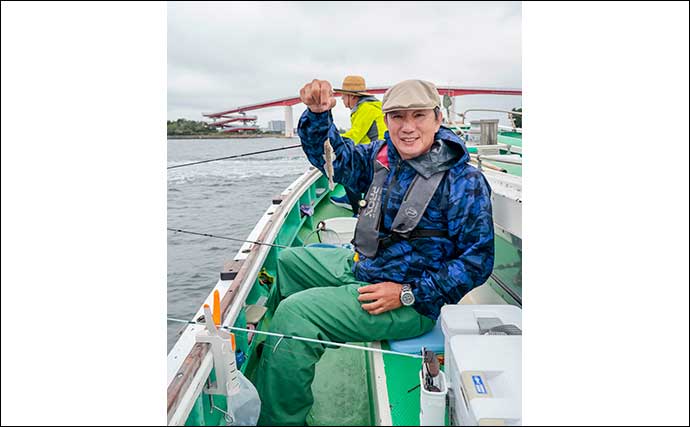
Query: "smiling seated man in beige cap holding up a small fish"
256 80 494 425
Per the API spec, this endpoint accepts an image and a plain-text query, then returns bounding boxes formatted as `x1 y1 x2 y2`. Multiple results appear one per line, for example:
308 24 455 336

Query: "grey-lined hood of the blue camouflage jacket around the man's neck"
386 126 470 179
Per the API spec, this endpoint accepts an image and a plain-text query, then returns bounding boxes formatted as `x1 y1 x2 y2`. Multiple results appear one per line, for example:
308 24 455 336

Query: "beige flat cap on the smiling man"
382 80 441 113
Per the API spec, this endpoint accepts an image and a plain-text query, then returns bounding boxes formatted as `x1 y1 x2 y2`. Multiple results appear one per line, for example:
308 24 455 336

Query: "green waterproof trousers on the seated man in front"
256 248 434 425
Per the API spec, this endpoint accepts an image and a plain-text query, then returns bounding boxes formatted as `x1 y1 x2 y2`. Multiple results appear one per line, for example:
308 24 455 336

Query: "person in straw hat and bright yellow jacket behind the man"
331 76 387 216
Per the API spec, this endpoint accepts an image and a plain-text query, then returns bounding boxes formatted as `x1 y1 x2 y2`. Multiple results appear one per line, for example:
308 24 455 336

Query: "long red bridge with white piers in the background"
203 86 522 136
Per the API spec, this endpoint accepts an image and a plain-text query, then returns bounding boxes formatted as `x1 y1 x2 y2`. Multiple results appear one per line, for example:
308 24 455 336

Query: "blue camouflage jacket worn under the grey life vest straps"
298 109 494 320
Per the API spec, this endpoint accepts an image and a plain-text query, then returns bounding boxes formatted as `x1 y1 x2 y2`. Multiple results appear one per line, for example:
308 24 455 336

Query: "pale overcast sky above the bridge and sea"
168 2 522 128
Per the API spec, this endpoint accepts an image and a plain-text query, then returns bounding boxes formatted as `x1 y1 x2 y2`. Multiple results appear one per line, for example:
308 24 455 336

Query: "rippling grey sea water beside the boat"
167 138 309 351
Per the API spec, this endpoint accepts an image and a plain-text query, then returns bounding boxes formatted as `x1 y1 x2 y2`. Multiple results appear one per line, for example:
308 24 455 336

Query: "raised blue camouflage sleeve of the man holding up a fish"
297 108 375 193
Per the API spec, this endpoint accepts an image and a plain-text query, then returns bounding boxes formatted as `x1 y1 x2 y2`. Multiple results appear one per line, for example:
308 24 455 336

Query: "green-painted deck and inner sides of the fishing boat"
169 168 521 426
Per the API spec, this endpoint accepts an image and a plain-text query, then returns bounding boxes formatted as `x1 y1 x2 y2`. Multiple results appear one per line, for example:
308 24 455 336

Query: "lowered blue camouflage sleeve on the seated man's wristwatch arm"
413 169 494 308
